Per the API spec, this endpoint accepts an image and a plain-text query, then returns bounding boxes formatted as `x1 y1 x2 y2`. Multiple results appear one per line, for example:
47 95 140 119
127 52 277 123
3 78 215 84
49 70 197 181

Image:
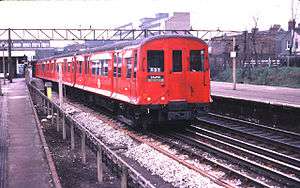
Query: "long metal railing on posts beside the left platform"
27 82 155 188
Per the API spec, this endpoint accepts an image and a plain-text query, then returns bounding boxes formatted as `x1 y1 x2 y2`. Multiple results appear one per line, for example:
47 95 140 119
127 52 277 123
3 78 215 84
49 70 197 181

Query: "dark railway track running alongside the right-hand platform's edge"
197 114 300 162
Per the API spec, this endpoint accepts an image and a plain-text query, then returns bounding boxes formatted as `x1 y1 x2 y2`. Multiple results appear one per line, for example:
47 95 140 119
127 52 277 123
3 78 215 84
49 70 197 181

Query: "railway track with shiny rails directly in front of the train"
154 128 300 187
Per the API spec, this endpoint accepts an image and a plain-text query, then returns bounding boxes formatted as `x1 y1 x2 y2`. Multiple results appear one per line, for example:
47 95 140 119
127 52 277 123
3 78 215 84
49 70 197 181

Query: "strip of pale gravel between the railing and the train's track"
53 95 224 188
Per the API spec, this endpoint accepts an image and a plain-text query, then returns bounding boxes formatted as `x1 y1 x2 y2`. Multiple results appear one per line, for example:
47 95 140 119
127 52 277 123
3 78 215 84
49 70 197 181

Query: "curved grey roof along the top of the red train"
39 34 206 61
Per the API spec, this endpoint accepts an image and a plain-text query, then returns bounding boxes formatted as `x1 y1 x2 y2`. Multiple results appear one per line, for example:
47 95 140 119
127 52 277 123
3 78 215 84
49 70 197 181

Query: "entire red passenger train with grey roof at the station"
35 35 210 126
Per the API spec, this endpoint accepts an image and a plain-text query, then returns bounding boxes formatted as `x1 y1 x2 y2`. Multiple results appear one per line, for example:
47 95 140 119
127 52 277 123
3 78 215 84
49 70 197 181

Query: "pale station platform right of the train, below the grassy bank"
211 81 300 108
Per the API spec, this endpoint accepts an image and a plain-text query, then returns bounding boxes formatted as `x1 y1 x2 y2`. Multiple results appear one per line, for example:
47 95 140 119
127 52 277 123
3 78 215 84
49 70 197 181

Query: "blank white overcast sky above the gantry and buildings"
0 0 300 30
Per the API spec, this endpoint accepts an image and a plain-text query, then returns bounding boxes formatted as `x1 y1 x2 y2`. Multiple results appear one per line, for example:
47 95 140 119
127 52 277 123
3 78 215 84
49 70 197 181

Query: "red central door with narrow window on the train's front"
166 48 187 101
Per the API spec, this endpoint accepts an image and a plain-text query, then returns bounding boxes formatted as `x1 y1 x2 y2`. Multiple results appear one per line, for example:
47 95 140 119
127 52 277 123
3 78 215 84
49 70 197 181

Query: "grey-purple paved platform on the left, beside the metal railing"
0 79 54 188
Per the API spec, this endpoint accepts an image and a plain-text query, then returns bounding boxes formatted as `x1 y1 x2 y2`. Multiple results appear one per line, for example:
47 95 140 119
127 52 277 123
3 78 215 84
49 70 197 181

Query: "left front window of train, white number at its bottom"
147 50 164 72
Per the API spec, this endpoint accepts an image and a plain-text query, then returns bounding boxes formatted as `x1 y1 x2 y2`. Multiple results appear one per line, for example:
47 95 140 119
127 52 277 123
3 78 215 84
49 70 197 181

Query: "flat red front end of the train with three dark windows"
138 36 210 122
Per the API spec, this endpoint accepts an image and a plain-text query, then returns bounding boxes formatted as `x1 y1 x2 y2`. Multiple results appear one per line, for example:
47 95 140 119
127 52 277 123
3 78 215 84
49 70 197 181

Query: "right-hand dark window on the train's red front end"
190 50 204 72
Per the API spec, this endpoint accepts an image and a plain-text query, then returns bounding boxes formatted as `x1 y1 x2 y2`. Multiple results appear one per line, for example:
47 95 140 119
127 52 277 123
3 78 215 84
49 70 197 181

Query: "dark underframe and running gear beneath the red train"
49 83 208 129
